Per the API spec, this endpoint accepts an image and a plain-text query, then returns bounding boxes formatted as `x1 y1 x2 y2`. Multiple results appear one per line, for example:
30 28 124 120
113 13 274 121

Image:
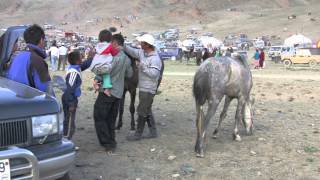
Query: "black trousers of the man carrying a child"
93 93 120 148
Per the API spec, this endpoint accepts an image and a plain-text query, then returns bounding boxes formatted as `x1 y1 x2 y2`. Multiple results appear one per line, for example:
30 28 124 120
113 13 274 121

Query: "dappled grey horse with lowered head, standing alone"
193 56 253 157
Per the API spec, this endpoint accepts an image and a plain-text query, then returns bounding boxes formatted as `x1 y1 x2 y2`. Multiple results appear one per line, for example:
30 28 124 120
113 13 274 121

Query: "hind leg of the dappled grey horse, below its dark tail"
196 96 223 157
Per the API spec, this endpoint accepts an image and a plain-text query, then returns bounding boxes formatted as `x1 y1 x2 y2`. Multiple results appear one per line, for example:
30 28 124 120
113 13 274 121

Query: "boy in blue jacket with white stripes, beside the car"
62 51 82 139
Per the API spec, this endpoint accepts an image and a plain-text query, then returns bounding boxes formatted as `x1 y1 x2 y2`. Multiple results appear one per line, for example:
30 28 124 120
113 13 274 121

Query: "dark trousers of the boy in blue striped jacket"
62 102 77 139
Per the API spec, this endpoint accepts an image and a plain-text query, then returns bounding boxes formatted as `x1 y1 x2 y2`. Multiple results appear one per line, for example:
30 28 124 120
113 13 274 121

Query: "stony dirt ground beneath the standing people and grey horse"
53 58 320 180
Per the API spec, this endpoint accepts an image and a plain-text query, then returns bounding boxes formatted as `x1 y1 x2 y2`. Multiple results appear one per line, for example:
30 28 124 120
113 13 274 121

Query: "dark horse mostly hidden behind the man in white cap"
116 54 164 130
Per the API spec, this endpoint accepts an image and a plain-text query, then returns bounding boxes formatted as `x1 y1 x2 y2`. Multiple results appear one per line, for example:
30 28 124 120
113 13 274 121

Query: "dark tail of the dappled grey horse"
193 66 211 106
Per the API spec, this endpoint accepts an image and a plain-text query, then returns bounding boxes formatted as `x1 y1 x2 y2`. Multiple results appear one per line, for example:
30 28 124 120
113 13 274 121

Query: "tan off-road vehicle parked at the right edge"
281 48 320 68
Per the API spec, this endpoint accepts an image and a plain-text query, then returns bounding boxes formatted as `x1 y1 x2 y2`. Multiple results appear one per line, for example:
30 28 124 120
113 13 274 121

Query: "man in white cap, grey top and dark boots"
124 34 163 141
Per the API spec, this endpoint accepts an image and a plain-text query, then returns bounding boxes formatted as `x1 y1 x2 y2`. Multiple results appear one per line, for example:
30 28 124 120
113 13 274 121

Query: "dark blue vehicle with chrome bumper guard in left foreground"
0 26 75 180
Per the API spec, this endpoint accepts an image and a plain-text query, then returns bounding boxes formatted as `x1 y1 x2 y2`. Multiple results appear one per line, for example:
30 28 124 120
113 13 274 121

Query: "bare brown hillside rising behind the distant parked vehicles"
0 0 320 38
